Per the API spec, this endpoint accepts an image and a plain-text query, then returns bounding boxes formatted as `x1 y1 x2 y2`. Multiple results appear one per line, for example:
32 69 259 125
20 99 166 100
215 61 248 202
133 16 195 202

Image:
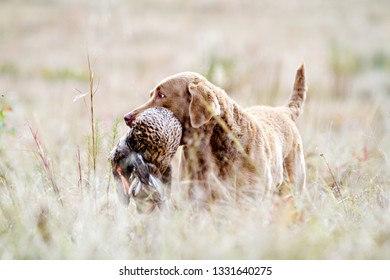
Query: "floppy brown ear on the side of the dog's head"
188 83 221 128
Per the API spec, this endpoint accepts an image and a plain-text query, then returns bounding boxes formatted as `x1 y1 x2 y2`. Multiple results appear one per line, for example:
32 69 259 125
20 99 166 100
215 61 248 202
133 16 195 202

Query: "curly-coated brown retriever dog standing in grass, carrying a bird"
124 65 306 199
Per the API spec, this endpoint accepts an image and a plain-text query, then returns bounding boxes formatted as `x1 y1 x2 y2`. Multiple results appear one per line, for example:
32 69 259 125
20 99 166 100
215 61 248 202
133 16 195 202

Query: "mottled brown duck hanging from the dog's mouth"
110 107 182 212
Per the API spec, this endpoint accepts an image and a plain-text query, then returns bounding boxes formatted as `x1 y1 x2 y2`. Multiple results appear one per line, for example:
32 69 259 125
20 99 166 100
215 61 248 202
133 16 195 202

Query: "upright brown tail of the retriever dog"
287 63 306 121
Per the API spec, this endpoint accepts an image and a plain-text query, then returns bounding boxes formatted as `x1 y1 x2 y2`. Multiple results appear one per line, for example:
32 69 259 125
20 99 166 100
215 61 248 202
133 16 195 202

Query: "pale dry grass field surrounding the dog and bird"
0 0 390 259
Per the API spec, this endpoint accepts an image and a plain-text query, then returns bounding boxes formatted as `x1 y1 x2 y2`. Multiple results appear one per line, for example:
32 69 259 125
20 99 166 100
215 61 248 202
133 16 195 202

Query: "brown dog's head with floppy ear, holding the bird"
124 72 220 128
